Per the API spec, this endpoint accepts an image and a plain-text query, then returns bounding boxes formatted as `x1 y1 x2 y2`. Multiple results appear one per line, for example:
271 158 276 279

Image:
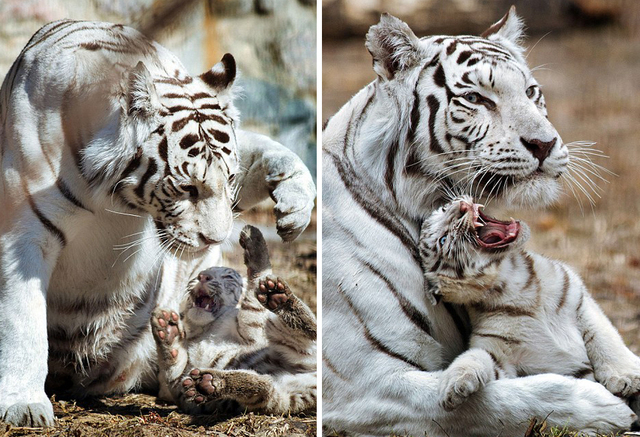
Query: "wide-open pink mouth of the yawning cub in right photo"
460 202 520 249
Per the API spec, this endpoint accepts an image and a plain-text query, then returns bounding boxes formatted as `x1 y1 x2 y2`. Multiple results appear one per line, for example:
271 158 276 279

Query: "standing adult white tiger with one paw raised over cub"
0 21 315 426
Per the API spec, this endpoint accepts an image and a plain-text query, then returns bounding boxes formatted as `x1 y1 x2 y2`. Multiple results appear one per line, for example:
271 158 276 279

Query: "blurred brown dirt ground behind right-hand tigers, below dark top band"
323 27 640 354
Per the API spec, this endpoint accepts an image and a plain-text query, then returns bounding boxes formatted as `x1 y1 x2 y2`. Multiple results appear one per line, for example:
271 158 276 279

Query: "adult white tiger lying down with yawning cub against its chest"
322 8 634 436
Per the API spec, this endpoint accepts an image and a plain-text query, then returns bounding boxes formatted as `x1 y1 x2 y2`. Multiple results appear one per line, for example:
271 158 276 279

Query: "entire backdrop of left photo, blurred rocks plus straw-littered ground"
0 0 317 437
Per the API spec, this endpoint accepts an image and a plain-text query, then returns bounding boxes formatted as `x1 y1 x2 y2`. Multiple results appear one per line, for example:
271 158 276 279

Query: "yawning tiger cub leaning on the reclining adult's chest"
420 197 640 411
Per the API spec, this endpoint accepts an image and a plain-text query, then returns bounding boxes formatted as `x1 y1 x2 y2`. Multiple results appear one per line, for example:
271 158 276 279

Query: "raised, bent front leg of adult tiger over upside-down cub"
237 130 316 241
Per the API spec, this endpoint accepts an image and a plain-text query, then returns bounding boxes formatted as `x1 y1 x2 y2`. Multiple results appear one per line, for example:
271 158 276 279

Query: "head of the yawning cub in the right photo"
420 196 530 279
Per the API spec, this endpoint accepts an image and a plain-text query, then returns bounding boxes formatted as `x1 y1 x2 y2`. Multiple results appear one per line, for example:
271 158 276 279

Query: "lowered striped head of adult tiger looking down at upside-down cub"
114 54 238 253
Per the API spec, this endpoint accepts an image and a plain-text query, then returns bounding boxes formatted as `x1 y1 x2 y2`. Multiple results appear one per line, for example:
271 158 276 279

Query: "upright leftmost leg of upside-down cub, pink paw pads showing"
151 308 189 401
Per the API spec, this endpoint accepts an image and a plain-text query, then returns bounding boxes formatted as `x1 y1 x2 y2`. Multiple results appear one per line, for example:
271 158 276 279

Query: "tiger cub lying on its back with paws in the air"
151 225 317 414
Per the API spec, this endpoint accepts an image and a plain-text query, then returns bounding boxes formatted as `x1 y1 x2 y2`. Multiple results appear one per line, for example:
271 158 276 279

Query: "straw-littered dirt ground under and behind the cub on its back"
0 208 317 437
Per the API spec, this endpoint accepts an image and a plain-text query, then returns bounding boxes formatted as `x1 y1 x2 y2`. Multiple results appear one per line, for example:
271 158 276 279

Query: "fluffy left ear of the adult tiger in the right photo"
366 13 420 80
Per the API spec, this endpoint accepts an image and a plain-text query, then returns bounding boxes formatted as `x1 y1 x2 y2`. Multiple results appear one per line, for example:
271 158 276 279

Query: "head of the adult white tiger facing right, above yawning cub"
366 7 569 215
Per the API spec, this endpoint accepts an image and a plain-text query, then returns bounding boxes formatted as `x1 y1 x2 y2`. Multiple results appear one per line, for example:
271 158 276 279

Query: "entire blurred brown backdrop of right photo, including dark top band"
322 0 640 353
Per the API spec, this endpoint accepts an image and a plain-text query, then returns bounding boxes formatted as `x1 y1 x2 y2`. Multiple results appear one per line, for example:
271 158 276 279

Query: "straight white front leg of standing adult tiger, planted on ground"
0 225 57 427
